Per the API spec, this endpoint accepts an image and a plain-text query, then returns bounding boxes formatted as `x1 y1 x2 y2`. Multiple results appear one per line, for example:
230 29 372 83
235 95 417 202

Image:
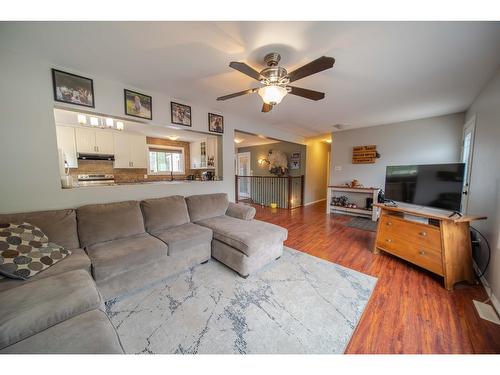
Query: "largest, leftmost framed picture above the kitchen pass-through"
52 69 95 108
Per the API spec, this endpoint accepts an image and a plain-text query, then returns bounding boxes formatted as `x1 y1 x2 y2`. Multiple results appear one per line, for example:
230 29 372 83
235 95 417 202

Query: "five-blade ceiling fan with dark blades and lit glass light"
217 52 335 112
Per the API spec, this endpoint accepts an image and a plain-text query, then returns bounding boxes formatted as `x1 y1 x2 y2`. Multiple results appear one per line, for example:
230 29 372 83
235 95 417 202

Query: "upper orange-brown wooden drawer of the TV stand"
379 216 441 251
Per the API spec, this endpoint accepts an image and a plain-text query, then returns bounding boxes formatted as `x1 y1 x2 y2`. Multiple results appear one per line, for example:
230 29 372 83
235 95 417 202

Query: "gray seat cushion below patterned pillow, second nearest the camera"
0 270 102 349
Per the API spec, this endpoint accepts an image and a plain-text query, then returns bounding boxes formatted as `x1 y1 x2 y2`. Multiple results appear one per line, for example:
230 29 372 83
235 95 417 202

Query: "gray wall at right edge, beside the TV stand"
466 69 500 309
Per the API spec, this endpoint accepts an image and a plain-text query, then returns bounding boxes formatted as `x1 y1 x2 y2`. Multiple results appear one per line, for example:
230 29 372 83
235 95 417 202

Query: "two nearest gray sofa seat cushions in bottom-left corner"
0 270 123 353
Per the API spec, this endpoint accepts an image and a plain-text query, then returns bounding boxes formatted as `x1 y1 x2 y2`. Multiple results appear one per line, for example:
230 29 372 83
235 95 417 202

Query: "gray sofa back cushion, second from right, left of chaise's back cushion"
141 195 189 233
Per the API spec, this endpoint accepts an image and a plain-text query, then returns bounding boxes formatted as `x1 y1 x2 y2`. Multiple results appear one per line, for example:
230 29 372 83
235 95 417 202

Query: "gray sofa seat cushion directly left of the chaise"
151 223 212 255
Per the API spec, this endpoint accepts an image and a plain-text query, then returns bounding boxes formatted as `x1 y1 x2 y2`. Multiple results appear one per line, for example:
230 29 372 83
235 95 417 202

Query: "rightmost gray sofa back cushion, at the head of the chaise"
186 193 229 223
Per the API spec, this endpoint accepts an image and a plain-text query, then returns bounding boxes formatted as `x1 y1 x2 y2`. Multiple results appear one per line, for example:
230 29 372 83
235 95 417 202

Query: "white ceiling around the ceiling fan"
0 22 500 136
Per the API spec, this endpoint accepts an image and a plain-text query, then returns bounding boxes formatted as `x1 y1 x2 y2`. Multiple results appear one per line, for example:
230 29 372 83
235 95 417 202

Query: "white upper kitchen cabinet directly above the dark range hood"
75 128 114 155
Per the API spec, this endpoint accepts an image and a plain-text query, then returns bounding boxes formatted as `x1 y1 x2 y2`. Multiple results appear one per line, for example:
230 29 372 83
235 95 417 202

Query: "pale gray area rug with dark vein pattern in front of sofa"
106 248 377 354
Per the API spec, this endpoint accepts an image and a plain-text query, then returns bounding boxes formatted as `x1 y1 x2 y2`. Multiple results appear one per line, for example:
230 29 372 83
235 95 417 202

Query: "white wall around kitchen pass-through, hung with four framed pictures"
0 48 304 213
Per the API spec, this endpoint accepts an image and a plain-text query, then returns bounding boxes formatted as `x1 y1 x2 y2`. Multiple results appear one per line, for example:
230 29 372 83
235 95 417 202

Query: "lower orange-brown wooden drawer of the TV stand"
377 231 444 276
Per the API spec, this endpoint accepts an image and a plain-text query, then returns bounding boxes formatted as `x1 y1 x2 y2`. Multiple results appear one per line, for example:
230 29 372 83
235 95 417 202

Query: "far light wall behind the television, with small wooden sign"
330 113 464 189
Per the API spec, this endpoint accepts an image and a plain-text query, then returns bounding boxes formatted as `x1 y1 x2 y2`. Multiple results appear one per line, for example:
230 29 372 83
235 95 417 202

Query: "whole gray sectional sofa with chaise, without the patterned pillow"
0 194 287 353
